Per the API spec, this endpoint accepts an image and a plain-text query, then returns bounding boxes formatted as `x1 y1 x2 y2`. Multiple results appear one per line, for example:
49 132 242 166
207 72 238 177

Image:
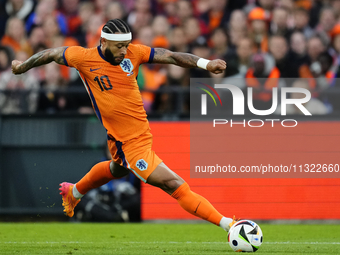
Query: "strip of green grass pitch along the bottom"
0 223 340 255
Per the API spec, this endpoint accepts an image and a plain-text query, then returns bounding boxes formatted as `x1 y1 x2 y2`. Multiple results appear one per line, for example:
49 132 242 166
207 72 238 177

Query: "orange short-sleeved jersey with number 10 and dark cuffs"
64 44 154 142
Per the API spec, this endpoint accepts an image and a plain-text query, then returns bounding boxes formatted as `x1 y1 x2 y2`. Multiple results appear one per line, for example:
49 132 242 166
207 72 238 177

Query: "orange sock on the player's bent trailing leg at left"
76 160 116 195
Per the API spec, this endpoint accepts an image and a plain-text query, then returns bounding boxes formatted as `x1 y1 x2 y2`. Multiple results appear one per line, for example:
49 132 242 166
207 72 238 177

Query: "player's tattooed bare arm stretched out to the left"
12 47 67 74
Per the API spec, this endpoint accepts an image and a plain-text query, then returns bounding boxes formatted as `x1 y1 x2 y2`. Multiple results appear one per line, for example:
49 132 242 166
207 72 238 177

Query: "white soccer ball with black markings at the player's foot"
228 220 263 252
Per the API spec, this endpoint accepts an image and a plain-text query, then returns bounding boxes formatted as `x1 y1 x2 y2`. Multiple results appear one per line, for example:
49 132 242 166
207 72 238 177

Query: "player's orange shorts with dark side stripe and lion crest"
107 129 162 182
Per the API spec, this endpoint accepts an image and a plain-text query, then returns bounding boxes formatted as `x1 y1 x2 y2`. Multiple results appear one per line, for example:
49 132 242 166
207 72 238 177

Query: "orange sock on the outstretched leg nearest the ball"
171 182 223 226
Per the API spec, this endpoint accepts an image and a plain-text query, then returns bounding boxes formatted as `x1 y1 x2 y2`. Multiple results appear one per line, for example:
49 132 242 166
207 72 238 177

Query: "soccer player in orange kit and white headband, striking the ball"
12 19 235 231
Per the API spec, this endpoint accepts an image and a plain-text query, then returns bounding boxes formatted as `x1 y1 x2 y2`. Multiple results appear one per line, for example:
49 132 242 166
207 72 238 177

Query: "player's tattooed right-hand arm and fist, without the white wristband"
153 48 227 74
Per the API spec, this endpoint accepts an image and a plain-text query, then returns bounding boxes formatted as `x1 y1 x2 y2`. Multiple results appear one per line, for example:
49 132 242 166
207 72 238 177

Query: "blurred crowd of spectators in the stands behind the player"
0 0 340 114
